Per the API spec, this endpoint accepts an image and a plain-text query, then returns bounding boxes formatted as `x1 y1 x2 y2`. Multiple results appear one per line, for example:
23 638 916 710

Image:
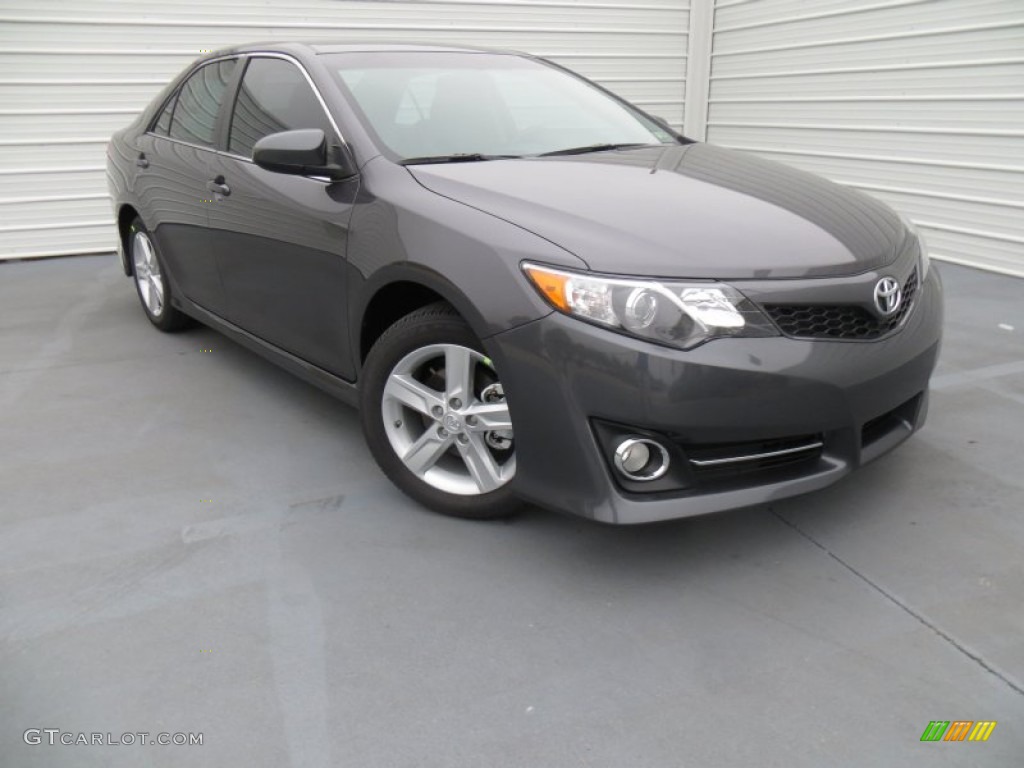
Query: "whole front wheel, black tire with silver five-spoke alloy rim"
359 303 520 520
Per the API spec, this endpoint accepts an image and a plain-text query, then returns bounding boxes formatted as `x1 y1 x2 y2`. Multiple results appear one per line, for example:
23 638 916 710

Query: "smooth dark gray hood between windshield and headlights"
408 143 907 280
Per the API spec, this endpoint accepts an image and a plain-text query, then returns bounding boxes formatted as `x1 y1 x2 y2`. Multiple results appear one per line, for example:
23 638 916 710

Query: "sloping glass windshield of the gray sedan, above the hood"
325 51 676 162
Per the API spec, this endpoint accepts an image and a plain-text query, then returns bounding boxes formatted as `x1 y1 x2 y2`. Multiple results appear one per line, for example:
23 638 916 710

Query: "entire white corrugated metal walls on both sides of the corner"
0 0 1024 274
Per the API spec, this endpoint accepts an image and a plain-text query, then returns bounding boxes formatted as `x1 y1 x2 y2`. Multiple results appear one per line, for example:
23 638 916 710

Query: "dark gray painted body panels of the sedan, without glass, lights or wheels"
109 44 941 522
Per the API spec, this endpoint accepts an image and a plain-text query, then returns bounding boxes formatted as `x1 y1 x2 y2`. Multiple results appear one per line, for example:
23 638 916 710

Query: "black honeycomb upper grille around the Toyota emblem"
764 269 918 341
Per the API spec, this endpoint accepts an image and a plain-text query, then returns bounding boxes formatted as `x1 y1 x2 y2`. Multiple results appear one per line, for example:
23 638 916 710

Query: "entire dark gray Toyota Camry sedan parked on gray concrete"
108 43 942 523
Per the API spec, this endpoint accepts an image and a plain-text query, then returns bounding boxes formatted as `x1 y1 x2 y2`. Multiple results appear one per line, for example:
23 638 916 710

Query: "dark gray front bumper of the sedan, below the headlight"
486 267 942 523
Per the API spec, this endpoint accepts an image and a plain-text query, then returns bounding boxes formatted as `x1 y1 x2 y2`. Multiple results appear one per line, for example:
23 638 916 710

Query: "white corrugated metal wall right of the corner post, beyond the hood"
695 0 1024 275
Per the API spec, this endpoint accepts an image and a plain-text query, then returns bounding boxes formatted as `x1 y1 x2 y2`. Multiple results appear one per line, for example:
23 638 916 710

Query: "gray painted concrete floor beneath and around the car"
0 256 1024 768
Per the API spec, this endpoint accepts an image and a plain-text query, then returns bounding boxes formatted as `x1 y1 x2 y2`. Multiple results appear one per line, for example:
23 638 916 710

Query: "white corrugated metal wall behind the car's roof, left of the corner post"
0 0 689 258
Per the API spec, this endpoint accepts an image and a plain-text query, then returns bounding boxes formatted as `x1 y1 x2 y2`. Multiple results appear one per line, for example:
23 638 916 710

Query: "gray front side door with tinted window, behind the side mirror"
209 55 358 379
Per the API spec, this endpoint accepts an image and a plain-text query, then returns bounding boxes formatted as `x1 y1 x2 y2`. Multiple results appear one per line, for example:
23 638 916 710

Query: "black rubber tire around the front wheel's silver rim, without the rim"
359 304 520 519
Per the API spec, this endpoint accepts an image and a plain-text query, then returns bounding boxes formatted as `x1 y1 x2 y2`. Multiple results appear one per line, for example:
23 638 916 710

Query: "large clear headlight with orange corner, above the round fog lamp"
522 263 778 349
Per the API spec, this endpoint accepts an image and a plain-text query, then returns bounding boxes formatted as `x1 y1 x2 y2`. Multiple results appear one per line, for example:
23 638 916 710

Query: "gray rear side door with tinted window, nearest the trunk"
134 58 239 314
